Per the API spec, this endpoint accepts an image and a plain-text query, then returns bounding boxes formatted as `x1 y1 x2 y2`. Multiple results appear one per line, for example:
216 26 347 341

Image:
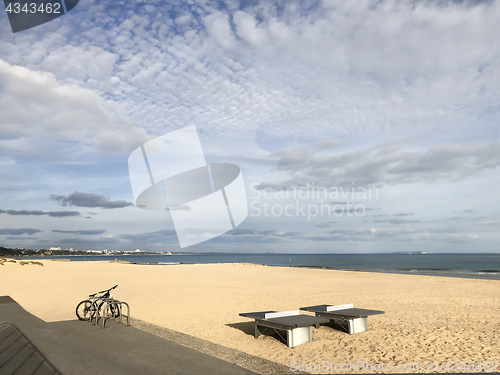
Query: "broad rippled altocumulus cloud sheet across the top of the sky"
4 0 500 156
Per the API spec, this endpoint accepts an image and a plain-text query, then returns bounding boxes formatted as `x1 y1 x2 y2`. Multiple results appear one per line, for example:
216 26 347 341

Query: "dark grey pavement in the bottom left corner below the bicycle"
0 297 254 375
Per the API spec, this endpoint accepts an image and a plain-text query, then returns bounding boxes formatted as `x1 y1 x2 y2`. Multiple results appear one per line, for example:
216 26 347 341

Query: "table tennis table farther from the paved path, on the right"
300 304 384 335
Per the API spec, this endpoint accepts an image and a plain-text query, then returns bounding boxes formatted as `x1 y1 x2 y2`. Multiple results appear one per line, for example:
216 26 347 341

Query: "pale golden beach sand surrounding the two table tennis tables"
0 260 500 373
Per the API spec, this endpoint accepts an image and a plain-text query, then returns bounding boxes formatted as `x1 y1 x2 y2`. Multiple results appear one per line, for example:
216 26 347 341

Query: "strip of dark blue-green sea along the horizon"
26 253 500 280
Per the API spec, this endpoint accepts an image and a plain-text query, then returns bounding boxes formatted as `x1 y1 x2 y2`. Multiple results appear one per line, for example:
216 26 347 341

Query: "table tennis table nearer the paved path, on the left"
239 310 329 348
